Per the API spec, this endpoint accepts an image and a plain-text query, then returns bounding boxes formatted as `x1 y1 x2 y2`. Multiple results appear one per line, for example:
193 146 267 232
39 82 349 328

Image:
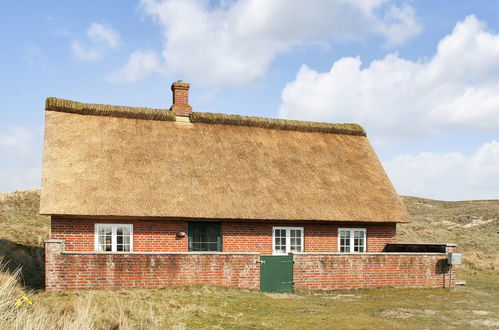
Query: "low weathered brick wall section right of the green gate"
293 253 455 290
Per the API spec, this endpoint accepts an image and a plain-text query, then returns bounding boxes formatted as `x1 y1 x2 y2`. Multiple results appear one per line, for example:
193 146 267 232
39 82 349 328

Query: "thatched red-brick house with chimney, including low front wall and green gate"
40 81 454 291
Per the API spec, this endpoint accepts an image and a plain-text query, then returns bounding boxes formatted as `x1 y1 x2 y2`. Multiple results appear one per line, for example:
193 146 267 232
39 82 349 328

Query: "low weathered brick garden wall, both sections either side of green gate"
45 240 455 290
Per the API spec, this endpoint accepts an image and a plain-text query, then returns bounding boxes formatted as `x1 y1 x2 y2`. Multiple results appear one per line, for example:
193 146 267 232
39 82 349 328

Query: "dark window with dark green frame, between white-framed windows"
188 222 222 252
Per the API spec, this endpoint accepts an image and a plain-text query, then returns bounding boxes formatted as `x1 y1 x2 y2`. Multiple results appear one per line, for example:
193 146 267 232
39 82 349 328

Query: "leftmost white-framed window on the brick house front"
95 224 133 252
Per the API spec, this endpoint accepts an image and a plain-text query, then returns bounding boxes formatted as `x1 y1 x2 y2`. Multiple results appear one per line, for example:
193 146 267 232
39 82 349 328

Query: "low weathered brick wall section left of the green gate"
45 240 260 290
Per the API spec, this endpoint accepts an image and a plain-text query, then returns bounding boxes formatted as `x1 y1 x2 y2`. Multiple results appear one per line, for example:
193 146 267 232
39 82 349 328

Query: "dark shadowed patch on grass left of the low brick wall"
0 239 45 290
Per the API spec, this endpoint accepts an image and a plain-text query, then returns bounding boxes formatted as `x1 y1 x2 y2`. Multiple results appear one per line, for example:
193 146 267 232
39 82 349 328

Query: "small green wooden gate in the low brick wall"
260 256 294 292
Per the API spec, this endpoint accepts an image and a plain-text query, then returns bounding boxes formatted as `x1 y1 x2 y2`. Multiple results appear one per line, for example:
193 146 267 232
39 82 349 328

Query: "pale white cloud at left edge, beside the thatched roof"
0 127 42 192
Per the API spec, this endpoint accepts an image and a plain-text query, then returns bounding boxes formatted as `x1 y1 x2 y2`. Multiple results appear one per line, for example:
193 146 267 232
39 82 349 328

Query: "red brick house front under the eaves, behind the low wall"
51 217 396 255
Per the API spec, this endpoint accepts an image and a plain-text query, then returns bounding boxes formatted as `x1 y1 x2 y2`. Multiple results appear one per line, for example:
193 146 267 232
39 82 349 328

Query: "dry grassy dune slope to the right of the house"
397 196 499 274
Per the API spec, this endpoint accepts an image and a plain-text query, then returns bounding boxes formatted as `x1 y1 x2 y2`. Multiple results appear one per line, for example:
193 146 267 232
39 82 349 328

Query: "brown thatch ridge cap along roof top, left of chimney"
45 97 175 121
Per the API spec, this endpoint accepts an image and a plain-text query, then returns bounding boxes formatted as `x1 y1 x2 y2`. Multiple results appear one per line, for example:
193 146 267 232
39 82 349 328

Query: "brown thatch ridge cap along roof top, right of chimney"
190 112 366 136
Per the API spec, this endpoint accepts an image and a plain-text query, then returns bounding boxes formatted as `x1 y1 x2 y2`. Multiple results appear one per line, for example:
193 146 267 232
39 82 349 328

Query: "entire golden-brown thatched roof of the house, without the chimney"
40 99 407 222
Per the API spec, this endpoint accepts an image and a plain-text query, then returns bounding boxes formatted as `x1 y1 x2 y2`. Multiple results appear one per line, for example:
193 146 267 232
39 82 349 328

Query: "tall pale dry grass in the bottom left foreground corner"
0 260 190 330
